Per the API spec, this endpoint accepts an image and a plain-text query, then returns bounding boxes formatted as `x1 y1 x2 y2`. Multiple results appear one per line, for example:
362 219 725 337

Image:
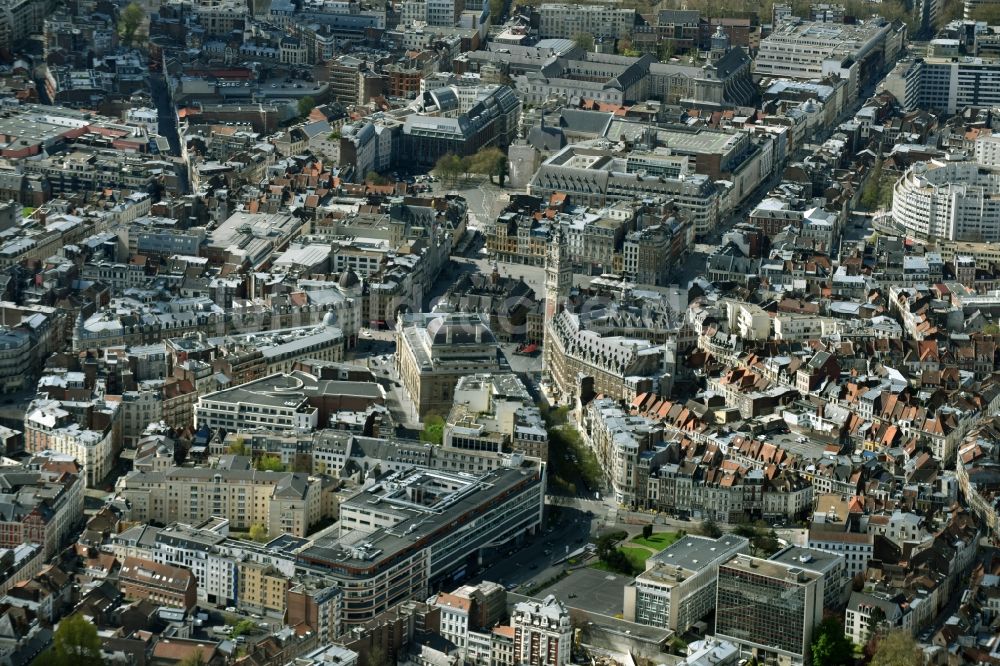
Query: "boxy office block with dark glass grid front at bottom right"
715 555 824 665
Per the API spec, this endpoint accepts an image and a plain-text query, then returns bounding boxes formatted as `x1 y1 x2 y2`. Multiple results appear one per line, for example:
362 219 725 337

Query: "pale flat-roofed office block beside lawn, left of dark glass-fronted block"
624 534 750 634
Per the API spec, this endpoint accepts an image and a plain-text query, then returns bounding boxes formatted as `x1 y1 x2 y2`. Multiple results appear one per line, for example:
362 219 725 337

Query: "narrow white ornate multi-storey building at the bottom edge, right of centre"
510 594 573 666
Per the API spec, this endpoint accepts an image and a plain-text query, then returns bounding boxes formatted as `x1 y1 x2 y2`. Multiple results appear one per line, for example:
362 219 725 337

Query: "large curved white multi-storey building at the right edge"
892 160 1000 243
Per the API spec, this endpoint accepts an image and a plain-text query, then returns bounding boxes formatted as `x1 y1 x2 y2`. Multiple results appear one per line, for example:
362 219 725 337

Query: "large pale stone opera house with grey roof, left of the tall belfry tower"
396 312 506 417
